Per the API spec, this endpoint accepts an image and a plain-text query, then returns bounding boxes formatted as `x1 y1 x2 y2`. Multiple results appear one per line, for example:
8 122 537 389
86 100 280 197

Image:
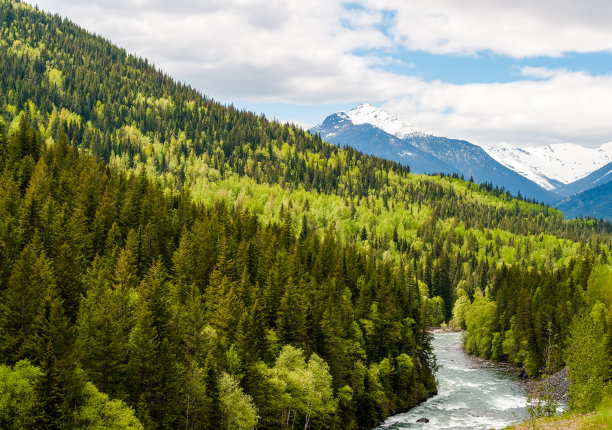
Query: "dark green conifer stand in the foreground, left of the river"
0 115 434 428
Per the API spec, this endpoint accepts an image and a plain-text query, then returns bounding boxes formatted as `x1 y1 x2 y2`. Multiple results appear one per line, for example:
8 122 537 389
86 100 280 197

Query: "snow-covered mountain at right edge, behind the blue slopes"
483 142 612 190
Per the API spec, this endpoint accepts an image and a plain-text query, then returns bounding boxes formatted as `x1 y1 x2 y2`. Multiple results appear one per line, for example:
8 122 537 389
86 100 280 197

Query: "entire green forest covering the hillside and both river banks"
0 0 612 429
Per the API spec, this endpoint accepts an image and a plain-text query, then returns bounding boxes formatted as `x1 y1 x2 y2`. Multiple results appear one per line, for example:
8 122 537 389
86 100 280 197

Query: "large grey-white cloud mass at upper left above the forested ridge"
33 0 394 103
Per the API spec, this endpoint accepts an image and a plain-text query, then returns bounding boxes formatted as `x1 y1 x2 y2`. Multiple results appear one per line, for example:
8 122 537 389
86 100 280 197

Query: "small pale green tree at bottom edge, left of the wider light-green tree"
219 373 259 430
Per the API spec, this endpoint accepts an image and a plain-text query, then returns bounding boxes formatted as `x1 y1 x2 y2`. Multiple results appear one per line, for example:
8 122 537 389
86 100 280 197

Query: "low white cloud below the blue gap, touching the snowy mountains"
386 71 612 146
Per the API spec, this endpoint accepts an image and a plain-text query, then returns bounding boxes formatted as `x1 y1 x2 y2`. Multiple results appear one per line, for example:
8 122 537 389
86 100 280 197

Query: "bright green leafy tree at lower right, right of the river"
566 312 611 412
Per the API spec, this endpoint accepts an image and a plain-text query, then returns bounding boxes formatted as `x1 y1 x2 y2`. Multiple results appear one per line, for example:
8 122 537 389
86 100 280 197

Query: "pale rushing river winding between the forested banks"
377 333 527 430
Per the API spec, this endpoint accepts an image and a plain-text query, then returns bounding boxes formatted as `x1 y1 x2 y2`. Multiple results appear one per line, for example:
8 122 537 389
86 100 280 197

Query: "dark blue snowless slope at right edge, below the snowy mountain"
557 181 612 221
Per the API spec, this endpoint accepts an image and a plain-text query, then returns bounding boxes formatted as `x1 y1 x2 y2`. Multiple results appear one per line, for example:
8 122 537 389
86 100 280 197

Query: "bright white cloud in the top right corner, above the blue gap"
364 0 612 58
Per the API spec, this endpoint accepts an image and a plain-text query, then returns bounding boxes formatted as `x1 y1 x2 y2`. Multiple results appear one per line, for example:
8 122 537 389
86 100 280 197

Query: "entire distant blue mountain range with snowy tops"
310 103 612 220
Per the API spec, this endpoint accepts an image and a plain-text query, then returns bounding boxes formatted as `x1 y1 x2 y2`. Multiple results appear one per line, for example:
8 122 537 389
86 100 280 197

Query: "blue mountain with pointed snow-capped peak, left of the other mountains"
310 103 560 203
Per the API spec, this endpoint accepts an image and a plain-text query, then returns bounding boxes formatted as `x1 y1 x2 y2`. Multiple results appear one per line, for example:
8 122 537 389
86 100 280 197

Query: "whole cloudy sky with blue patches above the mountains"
32 0 612 146
